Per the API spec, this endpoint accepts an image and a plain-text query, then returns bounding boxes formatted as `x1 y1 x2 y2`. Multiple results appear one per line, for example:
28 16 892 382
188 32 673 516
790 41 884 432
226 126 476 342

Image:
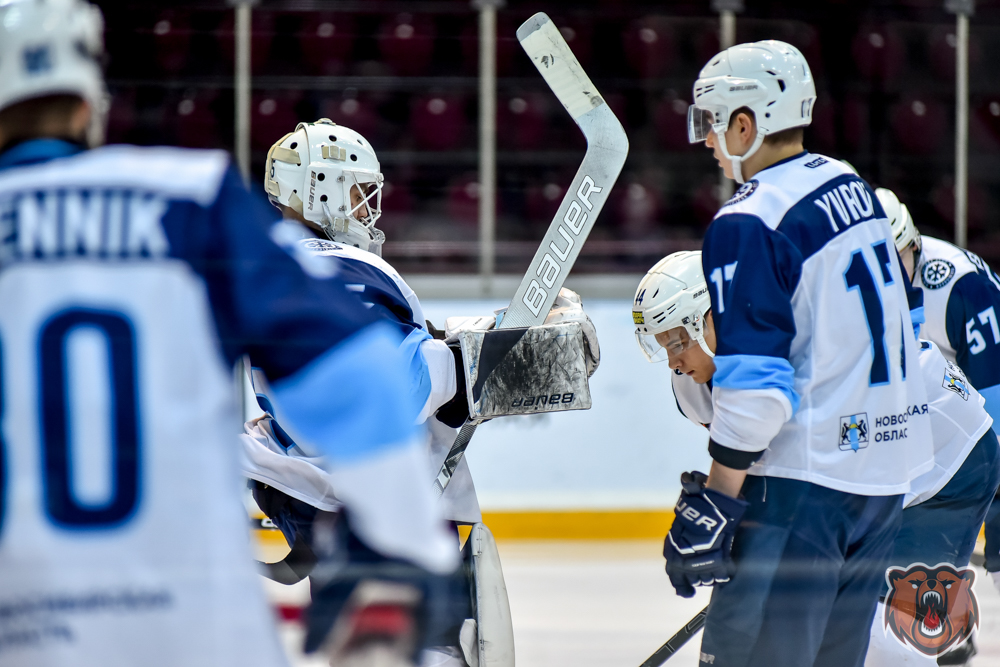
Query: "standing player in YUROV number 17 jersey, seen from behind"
668 41 933 667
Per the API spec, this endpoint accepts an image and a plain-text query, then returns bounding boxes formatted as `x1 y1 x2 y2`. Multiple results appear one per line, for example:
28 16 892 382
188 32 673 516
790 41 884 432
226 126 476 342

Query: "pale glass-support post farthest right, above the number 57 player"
944 0 975 248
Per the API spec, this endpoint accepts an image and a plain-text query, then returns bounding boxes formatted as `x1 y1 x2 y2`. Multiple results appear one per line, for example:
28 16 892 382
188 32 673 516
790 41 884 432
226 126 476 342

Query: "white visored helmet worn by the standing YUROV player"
688 39 816 183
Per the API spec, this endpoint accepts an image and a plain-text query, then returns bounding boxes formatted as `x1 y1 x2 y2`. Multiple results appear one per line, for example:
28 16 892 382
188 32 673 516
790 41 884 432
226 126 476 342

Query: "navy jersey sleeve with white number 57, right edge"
945 272 1000 421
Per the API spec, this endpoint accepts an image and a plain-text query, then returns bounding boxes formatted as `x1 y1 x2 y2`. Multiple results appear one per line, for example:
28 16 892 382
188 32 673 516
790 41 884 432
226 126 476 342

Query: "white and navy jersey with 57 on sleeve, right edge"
913 236 1000 434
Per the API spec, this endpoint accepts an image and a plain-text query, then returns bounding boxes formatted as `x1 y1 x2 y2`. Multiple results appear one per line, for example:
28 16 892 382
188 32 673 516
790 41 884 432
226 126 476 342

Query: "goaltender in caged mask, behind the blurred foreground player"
250 119 600 665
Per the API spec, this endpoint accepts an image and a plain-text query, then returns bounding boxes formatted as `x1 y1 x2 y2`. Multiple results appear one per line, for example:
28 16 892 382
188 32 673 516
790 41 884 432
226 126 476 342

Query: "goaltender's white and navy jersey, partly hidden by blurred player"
242 231 482 523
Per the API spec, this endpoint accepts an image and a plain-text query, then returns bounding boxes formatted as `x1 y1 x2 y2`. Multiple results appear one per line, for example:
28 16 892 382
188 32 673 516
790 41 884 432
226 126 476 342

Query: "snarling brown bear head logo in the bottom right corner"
883 563 979 656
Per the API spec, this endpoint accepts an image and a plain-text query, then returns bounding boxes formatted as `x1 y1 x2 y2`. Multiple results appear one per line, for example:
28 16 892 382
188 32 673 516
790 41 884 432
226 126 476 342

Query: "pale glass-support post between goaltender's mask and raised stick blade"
472 0 504 295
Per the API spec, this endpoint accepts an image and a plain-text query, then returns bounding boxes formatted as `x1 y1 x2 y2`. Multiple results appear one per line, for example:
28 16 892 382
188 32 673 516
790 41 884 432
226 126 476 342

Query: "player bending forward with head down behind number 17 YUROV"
633 252 1000 667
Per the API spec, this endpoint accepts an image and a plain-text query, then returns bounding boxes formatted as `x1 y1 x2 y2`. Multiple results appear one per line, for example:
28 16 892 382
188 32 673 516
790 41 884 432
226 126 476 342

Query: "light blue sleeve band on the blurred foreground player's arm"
271 322 426 465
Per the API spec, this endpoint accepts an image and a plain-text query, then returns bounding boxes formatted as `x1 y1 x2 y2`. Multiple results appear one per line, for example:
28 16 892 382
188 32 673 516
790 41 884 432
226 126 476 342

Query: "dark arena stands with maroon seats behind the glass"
97 0 1000 273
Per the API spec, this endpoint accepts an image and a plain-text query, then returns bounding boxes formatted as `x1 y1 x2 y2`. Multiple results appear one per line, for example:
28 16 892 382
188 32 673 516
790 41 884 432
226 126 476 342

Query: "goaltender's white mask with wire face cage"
264 118 385 255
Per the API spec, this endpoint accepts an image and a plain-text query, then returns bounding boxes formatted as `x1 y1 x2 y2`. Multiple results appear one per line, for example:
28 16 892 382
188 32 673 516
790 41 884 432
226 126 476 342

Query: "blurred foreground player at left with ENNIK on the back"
0 0 457 667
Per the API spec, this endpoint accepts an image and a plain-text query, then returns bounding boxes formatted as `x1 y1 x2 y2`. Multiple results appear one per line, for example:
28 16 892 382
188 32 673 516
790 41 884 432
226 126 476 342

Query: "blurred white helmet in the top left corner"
0 0 109 146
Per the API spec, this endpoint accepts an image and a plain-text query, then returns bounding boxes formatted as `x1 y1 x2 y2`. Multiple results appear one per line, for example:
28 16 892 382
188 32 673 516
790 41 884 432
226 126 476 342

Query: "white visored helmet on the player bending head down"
632 250 715 363
